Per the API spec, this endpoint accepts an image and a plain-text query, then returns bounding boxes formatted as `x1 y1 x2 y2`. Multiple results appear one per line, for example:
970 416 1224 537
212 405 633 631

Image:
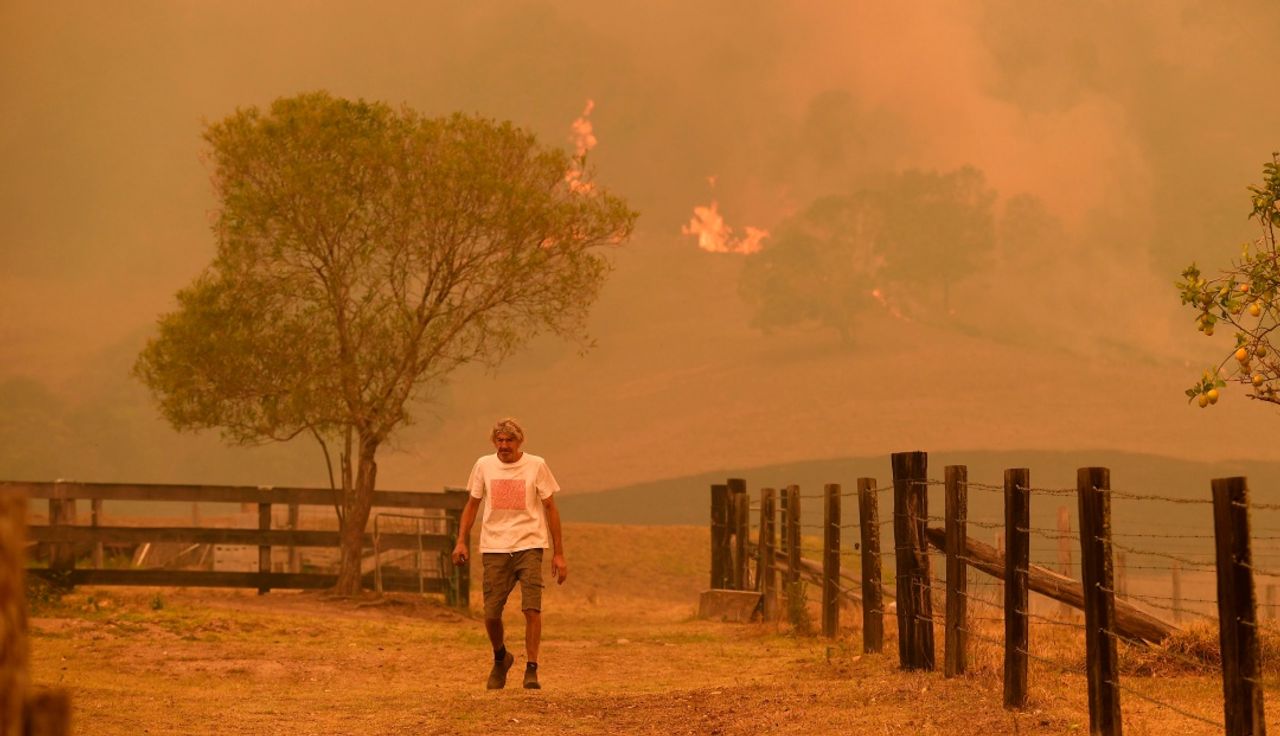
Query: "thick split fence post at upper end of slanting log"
892 452 933 669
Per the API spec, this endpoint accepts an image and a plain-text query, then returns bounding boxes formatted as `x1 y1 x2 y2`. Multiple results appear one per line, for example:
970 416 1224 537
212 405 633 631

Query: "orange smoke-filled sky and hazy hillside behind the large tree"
0 0 1280 489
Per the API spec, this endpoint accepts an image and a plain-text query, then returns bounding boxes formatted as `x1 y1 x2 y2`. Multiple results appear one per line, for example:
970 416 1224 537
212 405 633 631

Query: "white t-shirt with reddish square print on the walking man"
467 452 559 552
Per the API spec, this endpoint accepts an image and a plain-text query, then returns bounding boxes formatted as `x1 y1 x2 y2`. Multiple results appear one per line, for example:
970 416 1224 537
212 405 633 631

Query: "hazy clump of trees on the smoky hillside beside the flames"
740 166 996 343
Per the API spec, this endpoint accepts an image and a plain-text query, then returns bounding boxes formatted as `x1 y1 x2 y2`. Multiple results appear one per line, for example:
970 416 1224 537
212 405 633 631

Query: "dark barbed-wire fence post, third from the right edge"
1005 467 1032 708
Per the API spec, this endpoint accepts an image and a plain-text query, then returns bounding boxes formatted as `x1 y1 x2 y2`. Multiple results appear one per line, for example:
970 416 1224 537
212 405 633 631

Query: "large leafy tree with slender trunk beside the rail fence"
134 92 636 595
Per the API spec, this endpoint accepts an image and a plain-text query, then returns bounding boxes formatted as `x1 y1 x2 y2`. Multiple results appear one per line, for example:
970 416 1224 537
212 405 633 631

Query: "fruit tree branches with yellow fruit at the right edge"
1178 154 1280 407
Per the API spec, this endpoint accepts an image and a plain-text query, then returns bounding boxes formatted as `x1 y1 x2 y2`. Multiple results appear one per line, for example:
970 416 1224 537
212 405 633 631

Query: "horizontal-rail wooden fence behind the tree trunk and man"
0 481 471 608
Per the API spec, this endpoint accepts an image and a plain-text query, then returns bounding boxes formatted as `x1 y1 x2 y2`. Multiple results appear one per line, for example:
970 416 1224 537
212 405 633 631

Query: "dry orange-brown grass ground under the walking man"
31 525 1264 736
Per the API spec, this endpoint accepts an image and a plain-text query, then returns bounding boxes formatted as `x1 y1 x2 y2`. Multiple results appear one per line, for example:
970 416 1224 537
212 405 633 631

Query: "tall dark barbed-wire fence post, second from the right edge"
1075 467 1120 736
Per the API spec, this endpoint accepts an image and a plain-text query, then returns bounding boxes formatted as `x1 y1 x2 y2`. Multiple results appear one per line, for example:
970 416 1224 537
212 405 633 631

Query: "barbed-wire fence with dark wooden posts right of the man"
712 452 1280 736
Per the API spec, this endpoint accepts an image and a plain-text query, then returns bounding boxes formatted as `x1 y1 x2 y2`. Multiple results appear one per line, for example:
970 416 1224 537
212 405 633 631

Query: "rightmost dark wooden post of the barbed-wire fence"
1213 477 1266 736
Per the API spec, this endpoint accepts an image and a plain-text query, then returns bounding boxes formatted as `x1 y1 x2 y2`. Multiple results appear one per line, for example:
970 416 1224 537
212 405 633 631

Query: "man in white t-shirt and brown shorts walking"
453 419 568 690
